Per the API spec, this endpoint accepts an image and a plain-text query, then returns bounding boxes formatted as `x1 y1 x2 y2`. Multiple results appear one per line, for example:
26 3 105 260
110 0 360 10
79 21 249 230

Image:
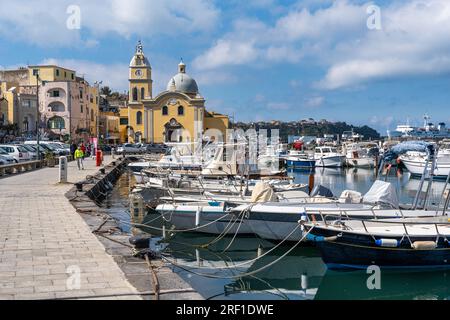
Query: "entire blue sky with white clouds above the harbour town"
0 0 450 134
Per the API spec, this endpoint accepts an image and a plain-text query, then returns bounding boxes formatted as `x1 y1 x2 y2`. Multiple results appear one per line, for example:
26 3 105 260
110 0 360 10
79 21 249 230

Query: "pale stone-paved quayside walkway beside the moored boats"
0 157 140 299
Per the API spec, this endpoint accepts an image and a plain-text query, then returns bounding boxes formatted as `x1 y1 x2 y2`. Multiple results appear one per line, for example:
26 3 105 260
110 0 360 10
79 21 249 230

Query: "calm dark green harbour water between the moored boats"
106 169 450 300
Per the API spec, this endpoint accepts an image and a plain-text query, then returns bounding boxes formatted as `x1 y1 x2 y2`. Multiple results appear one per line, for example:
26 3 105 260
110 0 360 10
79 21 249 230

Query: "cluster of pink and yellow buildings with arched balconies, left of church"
0 65 99 141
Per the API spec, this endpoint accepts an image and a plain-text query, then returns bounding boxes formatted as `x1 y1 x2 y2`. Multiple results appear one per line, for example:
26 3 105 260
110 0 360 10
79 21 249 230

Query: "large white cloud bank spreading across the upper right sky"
195 0 450 90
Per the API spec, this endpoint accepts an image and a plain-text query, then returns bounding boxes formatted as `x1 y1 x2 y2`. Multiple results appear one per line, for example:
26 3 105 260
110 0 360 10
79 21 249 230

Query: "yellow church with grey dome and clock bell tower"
120 41 229 143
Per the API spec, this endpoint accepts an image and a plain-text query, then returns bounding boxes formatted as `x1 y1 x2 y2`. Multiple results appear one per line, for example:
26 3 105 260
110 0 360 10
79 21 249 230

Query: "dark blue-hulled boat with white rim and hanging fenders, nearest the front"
304 216 450 269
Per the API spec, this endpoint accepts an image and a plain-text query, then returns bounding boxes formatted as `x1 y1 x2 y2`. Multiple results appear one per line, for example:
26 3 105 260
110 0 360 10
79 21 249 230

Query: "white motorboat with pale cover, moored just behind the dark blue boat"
231 181 442 241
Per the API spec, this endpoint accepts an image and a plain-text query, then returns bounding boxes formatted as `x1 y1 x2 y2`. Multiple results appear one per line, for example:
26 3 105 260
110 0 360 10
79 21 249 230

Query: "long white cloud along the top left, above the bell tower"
0 0 220 47
